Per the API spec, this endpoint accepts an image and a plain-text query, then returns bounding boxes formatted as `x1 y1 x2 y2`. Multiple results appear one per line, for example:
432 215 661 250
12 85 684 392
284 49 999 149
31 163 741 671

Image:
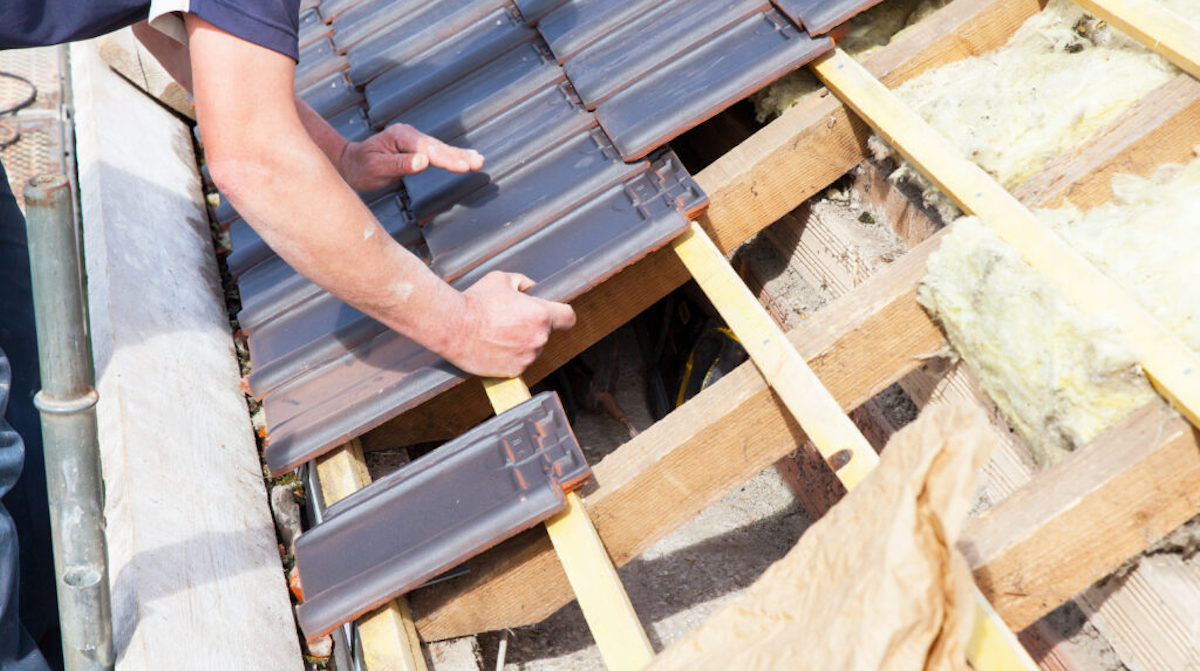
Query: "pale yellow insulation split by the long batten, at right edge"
918 154 1200 463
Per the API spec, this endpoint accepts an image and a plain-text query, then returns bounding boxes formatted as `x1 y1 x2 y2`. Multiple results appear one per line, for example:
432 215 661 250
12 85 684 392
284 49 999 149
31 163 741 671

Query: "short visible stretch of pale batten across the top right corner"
1075 0 1200 77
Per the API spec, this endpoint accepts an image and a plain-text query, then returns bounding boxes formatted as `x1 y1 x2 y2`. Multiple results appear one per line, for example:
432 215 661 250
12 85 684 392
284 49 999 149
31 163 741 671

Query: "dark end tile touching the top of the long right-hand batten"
595 8 833 160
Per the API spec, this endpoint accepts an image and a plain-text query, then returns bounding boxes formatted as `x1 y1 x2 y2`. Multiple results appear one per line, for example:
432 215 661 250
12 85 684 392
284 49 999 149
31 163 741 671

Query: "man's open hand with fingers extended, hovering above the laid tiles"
337 124 484 192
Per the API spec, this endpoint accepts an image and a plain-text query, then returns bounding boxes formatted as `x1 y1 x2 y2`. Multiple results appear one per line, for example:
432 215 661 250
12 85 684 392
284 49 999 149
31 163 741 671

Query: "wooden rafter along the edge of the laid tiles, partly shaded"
364 0 1044 449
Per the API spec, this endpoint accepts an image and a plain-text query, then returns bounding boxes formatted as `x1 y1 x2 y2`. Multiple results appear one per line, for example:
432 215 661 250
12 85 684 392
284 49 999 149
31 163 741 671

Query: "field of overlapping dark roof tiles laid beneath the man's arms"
217 0 874 473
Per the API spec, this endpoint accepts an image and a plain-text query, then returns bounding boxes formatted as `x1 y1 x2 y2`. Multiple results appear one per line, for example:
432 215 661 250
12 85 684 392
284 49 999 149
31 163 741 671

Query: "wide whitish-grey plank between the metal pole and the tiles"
72 39 304 671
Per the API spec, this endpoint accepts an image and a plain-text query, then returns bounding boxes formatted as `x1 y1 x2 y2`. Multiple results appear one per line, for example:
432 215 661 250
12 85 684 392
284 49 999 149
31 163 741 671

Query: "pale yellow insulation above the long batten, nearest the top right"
894 0 1180 188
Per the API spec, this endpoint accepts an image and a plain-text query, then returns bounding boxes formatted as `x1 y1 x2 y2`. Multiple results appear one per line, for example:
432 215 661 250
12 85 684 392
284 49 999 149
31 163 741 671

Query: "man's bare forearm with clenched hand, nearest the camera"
175 14 575 377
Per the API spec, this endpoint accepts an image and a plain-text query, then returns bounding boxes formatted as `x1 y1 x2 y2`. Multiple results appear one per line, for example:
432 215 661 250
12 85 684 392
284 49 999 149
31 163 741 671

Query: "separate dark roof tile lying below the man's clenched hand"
296 393 590 637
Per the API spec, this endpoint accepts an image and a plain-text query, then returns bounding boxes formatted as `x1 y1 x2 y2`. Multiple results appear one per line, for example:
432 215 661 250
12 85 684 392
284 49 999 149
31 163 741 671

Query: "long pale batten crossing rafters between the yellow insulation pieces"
812 49 1200 425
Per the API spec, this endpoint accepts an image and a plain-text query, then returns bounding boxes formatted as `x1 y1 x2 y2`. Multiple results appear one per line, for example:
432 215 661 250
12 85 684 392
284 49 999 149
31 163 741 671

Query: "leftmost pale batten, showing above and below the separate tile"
317 439 426 671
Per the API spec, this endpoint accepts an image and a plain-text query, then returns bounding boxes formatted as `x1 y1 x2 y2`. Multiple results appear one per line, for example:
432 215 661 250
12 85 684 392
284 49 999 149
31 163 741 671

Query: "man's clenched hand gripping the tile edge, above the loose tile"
440 270 575 377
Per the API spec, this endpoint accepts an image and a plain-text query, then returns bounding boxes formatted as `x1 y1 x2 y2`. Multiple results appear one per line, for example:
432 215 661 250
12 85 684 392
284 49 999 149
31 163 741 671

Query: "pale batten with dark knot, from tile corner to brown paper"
672 223 880 490
